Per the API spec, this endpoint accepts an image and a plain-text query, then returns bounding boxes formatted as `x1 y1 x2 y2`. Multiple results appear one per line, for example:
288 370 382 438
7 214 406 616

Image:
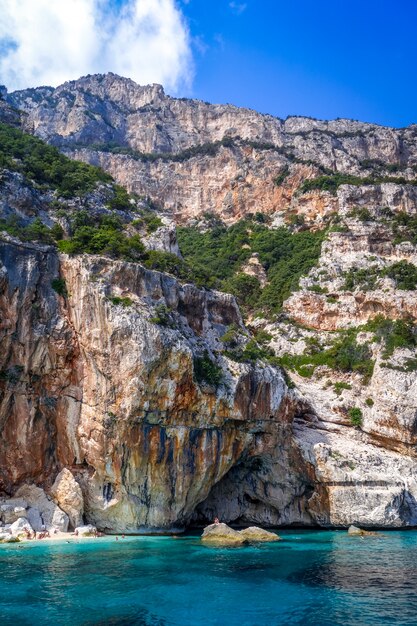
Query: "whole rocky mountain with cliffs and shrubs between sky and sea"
0 74 417 532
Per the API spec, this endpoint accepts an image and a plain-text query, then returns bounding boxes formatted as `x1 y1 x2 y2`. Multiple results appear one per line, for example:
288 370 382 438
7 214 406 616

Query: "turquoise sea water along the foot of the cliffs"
0 531 417 626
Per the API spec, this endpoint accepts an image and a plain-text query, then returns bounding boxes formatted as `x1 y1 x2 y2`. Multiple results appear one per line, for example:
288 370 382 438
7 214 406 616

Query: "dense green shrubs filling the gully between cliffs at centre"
178 218 325 312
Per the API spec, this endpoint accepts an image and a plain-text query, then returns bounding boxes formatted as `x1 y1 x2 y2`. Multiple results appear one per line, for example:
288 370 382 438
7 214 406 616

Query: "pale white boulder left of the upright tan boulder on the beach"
15 485 69 532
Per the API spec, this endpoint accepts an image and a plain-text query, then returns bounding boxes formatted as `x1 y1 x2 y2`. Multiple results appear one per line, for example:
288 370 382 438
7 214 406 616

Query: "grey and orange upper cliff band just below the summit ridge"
7 74 417 224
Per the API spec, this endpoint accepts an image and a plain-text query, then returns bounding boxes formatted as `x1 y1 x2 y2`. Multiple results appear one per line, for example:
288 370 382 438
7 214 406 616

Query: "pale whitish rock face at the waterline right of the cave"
295 424 417 528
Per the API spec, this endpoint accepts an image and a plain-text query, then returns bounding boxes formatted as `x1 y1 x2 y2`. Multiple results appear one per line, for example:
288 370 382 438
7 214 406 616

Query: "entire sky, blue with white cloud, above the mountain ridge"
0 0 417 126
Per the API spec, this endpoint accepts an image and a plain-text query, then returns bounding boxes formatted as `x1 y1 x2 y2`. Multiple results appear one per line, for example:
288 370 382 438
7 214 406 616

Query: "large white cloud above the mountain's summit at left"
0 0 193 92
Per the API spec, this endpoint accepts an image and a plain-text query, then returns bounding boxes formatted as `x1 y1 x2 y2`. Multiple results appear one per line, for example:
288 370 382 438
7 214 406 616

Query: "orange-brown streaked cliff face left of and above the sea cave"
0 240 302 531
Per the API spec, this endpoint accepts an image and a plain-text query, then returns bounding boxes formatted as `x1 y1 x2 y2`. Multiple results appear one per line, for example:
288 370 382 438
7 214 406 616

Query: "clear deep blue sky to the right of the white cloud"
180 0 417 126
